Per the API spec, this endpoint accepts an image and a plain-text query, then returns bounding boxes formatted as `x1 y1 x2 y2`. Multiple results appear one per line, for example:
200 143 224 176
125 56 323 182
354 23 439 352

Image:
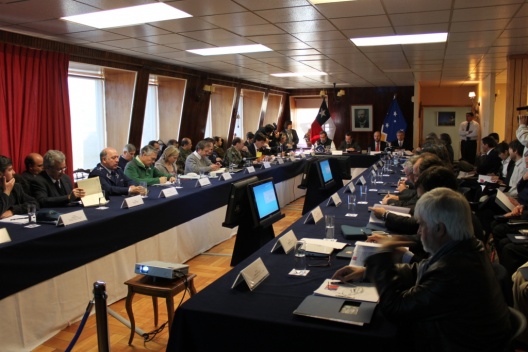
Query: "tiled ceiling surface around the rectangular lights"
0 0 528 88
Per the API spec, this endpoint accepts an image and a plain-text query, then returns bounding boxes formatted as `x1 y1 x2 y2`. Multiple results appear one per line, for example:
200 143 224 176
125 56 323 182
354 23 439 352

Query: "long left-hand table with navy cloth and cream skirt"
0 160 314 351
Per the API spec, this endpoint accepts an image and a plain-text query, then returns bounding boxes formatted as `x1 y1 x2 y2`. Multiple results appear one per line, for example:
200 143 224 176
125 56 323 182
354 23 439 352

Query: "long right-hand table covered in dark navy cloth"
167 159 401 352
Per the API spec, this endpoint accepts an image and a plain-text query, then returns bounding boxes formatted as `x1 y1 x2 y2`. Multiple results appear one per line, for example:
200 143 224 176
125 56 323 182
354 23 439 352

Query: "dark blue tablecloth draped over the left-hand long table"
0 160 305 299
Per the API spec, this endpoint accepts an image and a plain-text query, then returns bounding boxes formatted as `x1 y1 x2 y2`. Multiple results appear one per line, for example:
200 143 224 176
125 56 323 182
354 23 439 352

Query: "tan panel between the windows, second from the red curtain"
157 76 186 143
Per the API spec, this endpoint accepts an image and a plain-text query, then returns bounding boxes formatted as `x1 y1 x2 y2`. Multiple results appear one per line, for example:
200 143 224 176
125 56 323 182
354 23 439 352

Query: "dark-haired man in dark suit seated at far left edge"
0 155 39 219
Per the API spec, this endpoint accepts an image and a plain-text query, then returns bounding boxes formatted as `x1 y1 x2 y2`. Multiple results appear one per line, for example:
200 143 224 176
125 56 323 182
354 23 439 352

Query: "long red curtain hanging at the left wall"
0 43 73 176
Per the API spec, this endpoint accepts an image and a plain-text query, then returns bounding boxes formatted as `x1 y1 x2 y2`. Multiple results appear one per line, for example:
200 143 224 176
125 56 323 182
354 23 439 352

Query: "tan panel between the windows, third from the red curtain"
208 85 236 140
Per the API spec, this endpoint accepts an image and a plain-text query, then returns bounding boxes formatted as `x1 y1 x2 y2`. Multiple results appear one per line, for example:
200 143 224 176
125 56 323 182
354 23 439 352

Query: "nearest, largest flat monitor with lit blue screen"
248 178 284 227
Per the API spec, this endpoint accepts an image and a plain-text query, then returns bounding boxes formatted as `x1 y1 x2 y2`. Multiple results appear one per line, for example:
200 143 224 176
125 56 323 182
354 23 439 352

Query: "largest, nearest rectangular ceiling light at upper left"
61 2 192 28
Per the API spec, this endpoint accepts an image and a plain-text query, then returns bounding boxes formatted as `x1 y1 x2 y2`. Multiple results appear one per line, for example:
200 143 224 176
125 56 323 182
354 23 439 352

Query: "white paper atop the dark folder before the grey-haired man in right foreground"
314 279 379 302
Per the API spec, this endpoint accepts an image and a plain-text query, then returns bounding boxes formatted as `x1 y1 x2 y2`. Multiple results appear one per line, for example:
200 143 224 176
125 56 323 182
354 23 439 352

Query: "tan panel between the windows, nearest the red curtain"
104 68 138 152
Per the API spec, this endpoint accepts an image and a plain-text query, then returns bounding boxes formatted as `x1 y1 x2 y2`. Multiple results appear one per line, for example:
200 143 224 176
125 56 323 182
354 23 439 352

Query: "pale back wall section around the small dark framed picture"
423 106 469 160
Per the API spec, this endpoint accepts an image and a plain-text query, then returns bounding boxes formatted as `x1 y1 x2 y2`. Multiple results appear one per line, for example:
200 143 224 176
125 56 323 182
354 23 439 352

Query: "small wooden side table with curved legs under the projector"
125 274 196 345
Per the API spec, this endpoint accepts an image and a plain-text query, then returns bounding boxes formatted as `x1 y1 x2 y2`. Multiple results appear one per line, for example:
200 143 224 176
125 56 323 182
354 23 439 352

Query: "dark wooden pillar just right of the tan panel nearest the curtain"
128 69 150 148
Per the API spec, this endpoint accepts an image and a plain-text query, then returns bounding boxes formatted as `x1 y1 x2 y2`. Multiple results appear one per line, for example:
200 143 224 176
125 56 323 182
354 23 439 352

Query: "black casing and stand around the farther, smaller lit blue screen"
302 157 343 215
